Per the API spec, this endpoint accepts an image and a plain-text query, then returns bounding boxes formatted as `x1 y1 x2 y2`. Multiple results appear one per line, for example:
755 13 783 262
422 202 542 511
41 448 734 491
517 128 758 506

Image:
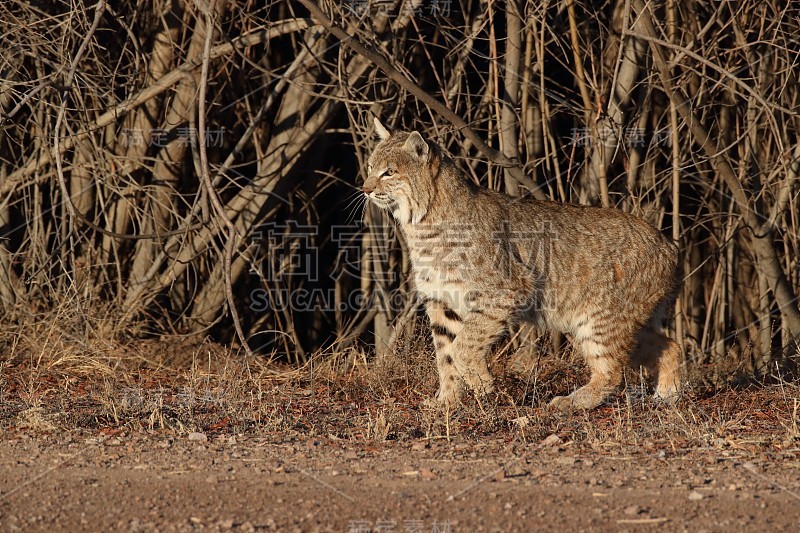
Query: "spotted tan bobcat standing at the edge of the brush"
363 118 681 411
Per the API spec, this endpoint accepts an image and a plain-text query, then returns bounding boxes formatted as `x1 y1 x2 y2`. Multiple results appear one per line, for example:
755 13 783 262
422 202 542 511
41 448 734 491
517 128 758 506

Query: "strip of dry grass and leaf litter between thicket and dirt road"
0 314 800 460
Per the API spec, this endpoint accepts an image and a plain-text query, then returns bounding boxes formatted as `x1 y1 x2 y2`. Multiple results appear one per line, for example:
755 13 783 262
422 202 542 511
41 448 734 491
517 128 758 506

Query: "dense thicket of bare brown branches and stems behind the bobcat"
0 0 800 375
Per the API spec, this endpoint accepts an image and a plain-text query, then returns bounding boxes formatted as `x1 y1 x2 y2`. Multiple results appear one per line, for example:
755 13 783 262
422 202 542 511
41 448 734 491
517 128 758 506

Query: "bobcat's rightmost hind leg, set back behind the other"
631 324 681 401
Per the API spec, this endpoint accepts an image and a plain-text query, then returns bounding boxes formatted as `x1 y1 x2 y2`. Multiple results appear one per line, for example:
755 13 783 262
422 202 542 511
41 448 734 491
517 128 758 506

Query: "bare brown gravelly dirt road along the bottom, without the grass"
0 420 800 532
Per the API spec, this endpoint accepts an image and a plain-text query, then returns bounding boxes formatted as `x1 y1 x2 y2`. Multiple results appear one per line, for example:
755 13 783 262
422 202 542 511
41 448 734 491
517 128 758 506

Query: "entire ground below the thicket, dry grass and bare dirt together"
0 336 800 532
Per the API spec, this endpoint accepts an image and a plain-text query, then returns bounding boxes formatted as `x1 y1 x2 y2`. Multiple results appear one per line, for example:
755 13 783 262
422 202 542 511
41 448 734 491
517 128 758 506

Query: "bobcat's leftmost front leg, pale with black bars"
426 300 464 406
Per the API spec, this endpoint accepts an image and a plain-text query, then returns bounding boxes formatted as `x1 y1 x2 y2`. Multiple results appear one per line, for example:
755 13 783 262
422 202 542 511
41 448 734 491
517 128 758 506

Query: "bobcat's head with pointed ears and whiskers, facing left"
362 118 433 224
